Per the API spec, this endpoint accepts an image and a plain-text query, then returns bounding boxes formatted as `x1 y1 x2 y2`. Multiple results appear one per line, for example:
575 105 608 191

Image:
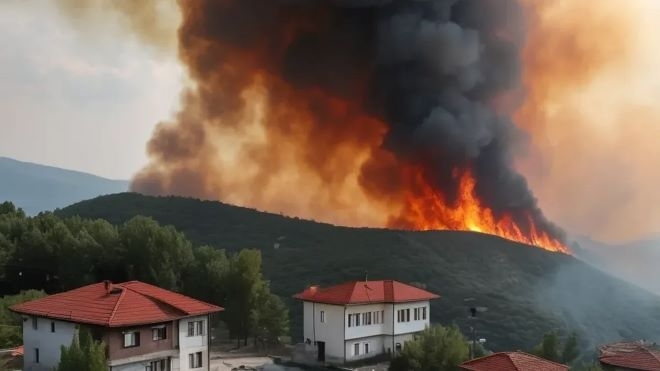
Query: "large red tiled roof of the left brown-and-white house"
10 281 223 327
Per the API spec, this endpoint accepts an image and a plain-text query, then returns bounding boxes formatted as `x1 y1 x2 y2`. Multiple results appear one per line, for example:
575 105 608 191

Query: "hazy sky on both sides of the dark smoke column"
0 0 660 242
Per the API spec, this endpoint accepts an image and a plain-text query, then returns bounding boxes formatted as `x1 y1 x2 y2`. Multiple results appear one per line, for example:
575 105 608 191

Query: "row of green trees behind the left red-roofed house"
0 202 289 345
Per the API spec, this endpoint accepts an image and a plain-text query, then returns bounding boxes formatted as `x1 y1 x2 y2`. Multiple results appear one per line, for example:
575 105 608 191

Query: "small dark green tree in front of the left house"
56 327 108 371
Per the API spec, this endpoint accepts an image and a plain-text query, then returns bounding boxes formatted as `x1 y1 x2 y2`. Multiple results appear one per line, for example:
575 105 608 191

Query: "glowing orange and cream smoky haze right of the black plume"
516 0 660 242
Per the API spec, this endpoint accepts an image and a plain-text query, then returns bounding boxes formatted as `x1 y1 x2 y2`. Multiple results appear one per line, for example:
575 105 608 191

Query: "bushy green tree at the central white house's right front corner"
389 325 469 371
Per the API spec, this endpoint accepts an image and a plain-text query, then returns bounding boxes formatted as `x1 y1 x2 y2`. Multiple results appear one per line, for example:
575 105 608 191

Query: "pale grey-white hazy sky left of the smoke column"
0 0 182 179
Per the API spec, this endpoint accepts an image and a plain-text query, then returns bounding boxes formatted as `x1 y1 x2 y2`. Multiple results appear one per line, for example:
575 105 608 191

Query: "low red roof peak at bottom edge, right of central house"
460 352 568 371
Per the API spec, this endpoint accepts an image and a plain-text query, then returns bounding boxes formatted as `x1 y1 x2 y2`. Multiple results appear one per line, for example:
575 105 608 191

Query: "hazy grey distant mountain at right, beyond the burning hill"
574 237 660 295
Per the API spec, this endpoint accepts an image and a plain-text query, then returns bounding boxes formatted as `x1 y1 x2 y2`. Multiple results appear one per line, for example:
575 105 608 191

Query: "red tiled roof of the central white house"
294 280 440 305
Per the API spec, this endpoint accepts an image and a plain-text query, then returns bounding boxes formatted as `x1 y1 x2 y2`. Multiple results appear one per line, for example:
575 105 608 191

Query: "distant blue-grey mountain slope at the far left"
0 157 129 215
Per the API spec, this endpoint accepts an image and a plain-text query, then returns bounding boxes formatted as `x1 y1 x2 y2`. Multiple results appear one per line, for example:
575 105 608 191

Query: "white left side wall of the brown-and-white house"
23 315 76 371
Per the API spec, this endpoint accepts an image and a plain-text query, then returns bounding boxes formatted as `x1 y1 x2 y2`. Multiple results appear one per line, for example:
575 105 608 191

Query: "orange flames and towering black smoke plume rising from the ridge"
127 0 569 252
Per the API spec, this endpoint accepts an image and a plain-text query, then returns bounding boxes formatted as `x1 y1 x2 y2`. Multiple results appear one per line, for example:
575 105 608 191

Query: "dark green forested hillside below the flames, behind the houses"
57 194 660 350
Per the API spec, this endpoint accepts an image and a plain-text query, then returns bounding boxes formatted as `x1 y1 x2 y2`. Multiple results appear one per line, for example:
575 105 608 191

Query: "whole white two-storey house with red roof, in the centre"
294 280 439 363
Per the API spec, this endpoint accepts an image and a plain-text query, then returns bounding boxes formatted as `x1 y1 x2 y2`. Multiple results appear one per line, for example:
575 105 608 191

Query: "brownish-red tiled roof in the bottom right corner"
598 342 660 371
